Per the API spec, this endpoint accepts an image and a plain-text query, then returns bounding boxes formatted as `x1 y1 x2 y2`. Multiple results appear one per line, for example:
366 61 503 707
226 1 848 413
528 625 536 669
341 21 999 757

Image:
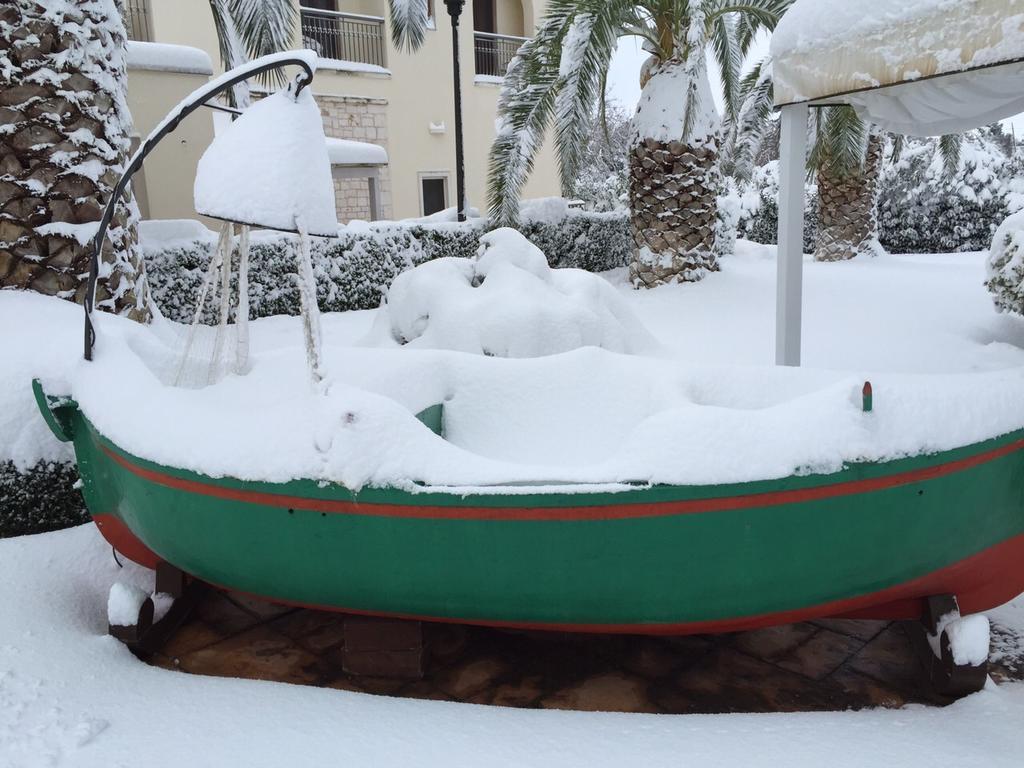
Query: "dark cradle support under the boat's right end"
914 595 988 698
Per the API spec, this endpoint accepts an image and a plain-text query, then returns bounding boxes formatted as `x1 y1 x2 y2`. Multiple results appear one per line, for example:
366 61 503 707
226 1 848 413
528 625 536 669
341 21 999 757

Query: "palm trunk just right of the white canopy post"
814 133 885 261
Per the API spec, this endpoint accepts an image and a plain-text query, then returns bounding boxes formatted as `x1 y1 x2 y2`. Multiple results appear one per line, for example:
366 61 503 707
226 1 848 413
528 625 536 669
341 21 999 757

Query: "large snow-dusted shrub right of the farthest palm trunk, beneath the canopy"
879 132 1024 253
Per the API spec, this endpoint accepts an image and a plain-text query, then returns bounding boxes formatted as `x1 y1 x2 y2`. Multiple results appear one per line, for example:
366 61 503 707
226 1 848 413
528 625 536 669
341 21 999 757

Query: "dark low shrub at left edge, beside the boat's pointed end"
0 461 89 539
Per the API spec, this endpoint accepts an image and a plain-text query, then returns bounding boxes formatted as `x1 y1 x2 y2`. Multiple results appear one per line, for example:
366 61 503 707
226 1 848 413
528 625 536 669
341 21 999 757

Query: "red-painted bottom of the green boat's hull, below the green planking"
207 535 1024 636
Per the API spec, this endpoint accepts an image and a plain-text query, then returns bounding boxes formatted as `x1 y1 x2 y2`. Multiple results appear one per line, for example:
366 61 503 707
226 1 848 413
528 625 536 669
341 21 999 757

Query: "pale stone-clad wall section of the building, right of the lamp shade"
316 94 392 223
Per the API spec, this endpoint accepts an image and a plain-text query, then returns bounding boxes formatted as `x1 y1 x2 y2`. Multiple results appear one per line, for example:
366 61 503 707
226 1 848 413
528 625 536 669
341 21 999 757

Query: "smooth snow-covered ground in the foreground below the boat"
0 526 1024 768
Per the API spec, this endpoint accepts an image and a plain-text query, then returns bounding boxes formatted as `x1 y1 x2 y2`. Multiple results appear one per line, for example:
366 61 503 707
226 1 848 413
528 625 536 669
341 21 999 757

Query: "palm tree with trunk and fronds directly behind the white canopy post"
725 59 961 261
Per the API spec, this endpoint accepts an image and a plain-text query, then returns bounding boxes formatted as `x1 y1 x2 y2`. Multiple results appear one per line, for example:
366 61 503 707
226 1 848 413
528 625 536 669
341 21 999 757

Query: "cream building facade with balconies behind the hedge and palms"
125 0 559 222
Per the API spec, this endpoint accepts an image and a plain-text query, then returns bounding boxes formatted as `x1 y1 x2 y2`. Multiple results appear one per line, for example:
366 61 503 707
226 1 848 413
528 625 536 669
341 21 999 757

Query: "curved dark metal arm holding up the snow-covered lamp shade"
84 53 313 360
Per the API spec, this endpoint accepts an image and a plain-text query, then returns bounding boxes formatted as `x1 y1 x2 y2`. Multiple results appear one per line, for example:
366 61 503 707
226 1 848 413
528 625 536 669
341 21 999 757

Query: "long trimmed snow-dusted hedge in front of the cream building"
142 201 632 322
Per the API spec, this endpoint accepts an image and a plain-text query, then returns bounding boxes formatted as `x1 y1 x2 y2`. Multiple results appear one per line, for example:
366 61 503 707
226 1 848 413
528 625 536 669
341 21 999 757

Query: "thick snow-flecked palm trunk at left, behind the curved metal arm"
0 0 150 321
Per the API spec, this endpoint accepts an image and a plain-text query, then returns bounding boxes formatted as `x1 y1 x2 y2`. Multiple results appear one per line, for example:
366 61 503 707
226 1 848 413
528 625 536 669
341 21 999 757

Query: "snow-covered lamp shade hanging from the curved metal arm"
195 88 338 238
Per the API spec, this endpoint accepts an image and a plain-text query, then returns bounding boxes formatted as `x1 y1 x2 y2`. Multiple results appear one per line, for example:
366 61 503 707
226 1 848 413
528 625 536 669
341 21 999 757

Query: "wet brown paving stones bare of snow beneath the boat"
152 590 1024 714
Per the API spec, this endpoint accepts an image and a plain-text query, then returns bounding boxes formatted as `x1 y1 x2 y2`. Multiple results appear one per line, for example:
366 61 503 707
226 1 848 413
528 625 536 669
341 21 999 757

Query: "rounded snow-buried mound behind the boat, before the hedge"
379 228 656 357
